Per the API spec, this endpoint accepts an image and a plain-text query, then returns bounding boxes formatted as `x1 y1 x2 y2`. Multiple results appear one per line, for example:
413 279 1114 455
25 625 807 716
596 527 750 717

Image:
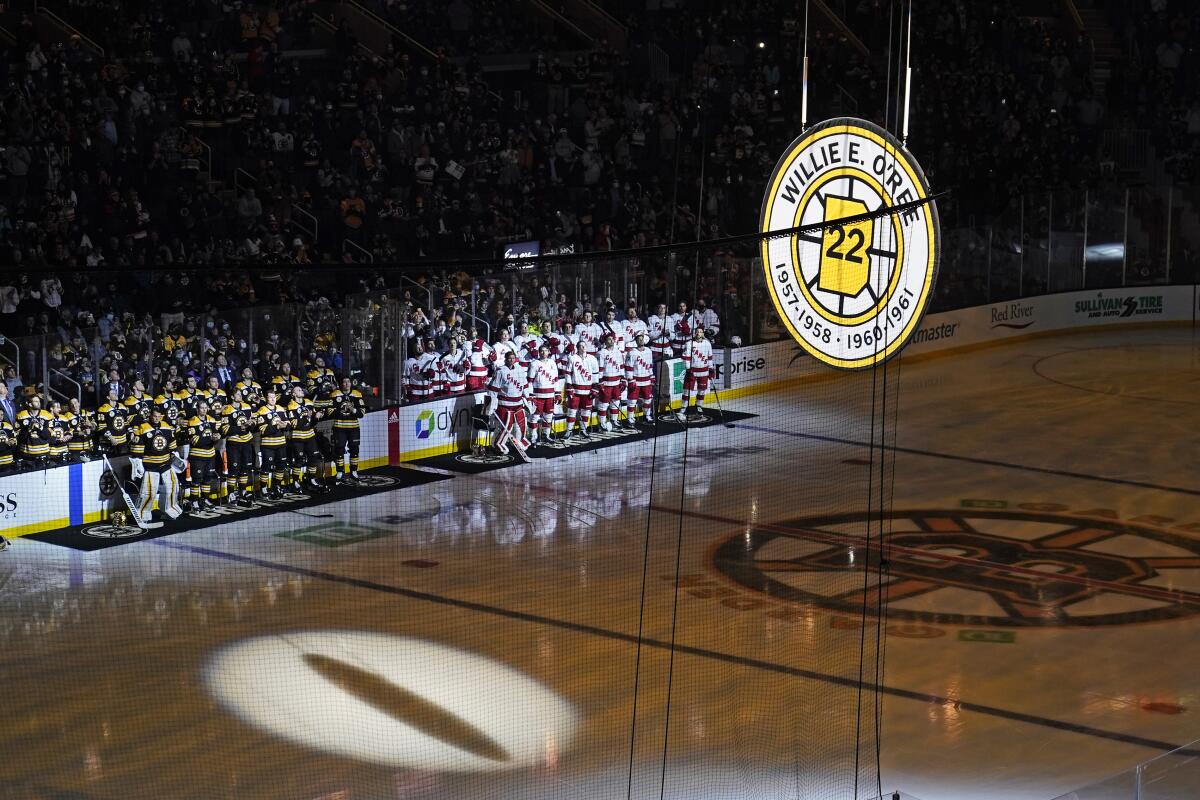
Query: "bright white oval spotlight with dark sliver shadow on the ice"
204 631 577 772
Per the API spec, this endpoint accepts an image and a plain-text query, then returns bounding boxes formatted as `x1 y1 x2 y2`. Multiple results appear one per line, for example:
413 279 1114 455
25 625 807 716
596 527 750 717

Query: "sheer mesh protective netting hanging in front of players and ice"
0 221 900 799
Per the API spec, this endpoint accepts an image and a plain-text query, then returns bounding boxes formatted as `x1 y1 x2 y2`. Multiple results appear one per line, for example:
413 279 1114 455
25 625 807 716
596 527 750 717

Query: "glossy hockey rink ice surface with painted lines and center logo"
0 327 1200 800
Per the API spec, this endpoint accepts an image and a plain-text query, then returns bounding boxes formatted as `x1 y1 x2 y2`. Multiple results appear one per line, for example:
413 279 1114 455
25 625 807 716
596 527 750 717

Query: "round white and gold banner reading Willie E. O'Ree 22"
760 118 941 369
